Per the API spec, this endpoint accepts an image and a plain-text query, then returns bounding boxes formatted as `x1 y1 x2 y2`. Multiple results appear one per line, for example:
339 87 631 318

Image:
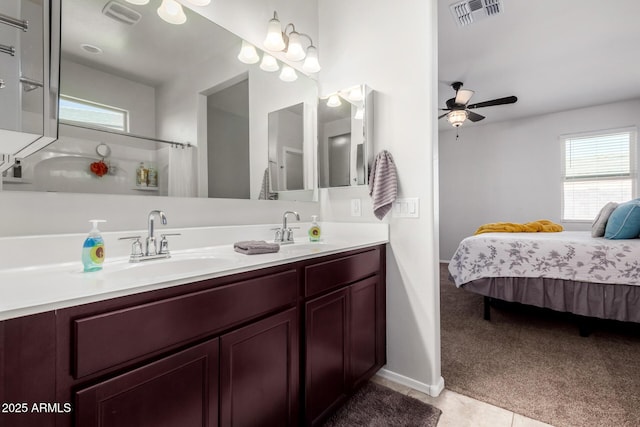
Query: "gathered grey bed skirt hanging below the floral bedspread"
462 277 640 323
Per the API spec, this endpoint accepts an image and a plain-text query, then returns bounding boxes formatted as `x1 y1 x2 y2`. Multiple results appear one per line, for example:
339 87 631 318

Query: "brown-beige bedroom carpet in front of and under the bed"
440 264 640 427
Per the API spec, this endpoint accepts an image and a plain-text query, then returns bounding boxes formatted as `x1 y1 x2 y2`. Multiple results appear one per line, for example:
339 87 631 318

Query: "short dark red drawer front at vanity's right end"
304 248 380 297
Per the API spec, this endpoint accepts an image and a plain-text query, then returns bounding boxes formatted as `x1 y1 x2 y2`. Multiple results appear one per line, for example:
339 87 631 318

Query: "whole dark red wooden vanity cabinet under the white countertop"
0 224 386 427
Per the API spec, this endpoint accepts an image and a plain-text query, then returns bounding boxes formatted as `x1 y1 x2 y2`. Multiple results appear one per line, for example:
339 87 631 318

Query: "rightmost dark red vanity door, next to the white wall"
349 276 385 388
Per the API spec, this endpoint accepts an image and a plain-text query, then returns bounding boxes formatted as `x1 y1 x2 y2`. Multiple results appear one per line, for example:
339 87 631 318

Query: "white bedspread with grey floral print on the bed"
449 231 640 287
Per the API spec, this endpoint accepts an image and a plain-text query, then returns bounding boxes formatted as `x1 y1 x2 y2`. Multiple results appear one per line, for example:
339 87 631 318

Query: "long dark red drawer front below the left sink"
72 270 298 378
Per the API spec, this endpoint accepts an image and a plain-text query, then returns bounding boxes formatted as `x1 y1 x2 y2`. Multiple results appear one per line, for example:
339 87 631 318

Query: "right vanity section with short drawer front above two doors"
304 248 386 425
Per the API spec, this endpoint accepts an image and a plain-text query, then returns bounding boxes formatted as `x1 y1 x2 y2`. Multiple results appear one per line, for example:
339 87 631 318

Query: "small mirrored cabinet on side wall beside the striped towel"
318 85 373 188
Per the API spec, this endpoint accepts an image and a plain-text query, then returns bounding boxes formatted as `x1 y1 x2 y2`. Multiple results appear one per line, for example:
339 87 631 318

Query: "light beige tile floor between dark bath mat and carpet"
373 376 552 427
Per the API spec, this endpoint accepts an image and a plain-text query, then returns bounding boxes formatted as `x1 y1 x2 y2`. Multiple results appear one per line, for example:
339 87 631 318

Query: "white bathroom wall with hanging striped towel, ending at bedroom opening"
319 0 443 394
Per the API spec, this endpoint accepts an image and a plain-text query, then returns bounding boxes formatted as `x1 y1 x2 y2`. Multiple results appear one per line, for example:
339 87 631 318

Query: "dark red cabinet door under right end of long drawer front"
220 308 300 427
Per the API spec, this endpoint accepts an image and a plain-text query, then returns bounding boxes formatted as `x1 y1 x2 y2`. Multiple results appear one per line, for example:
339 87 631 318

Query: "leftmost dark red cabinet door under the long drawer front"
75 339 218 427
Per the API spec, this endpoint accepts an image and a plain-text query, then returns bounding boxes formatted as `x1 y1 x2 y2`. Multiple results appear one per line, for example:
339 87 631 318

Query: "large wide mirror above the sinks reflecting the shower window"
3 0 318 200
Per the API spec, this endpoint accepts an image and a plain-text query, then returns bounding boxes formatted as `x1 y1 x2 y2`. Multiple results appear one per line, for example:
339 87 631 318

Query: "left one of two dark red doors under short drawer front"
305 288 349 425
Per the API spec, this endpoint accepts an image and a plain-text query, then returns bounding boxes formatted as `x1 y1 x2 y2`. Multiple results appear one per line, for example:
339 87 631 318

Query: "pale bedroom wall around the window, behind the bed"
439 100 640 260
